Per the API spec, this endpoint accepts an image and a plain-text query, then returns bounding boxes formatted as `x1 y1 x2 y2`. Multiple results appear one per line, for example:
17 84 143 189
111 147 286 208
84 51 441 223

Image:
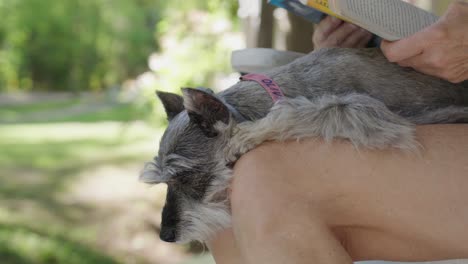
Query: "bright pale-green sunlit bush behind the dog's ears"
156 1 237 91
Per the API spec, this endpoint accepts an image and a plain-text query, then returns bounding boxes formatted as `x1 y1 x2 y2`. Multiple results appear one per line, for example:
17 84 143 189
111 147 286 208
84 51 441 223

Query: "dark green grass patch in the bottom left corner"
0 224 118 264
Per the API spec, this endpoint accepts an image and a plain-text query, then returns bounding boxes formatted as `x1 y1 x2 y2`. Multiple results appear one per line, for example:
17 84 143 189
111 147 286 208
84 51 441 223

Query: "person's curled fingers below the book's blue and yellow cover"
312 16 372 49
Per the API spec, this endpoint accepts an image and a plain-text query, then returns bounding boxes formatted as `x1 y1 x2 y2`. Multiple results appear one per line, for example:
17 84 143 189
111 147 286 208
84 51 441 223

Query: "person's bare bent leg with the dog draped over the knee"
212 125 468 263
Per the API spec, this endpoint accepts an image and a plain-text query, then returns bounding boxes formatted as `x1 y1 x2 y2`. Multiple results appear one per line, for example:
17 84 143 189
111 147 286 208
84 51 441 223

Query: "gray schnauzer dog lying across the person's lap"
140 49 468 243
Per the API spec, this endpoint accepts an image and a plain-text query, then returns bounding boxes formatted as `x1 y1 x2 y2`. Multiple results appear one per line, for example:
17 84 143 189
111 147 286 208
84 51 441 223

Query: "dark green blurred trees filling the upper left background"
0 0 159 91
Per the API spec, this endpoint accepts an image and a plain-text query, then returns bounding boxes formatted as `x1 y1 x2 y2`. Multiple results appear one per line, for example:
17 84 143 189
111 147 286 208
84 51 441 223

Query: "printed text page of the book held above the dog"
333 0 438 40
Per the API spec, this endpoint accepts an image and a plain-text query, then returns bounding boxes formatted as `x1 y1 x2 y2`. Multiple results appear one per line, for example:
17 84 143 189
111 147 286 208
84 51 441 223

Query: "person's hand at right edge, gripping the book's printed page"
381 1 468 83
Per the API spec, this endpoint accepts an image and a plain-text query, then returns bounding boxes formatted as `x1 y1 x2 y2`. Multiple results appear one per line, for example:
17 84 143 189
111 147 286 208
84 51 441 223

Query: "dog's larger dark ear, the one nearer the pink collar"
182 88 230 137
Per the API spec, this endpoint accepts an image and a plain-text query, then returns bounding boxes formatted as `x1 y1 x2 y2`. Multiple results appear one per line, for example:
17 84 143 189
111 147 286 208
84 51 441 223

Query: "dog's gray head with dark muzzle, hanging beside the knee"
140 88 234 243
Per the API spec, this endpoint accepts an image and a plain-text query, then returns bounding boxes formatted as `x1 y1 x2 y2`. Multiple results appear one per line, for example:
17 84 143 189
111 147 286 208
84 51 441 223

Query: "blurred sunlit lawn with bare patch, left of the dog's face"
0 95 212 264
